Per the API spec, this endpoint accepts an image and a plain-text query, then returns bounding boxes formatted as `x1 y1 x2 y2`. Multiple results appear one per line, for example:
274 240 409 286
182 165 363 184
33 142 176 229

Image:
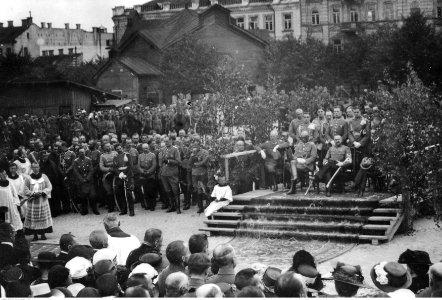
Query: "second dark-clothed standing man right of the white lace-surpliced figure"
59 142 77 212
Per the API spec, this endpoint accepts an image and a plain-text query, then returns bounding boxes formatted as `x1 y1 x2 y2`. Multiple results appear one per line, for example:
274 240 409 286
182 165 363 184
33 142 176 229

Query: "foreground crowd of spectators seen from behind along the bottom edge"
0 213 442 299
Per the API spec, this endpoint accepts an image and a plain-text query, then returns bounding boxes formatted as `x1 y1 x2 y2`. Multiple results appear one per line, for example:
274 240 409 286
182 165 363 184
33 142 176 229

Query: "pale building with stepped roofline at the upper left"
0 17 113 61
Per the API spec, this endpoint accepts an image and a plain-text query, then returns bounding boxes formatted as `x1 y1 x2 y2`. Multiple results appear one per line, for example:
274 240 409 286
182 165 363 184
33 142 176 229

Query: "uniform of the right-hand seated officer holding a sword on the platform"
315 145 351 196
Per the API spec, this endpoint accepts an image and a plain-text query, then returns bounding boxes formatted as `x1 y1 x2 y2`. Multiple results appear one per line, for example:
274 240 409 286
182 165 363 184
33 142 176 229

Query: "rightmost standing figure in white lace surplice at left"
24 163 52 241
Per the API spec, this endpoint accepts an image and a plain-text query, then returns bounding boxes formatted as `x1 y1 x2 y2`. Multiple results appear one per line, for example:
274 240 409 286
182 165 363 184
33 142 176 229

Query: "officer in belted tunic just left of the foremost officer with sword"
100 142 117 212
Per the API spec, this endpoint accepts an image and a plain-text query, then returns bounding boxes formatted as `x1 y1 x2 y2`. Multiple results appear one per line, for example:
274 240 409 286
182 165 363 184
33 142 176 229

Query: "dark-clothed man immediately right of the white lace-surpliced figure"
40 151 65 218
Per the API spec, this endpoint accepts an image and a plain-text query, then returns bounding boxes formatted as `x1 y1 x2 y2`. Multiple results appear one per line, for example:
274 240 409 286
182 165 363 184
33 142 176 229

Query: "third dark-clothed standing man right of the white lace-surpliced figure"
73 148 100 215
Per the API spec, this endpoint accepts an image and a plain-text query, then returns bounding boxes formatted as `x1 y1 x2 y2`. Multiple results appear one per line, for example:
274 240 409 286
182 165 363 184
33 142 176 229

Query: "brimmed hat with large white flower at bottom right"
370 261 412 293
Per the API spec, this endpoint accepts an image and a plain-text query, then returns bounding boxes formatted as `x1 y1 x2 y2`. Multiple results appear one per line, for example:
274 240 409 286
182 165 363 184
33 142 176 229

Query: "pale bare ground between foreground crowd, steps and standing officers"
35 204 442 296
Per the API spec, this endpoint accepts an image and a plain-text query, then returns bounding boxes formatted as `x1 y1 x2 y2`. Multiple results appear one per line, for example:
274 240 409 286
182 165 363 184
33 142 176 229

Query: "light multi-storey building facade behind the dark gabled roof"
112 0 301 43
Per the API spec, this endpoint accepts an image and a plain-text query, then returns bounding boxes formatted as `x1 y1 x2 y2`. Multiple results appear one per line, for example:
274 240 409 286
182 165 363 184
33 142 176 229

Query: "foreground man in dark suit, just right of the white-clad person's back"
126 228 163 269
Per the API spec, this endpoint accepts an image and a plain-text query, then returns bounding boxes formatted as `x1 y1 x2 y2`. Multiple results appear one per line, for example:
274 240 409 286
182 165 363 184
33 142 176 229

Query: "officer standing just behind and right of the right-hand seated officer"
348 107 371 174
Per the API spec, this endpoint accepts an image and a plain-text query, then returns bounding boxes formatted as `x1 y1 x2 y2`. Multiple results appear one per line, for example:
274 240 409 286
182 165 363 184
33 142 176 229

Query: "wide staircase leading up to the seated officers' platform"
200 190 403 244
